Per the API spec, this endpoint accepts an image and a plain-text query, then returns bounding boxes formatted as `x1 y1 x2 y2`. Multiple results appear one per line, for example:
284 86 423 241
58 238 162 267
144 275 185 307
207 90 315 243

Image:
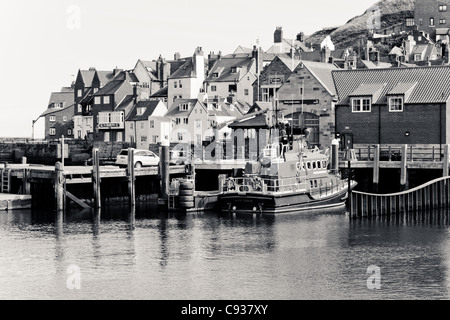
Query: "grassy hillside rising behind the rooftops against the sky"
306 0 414 49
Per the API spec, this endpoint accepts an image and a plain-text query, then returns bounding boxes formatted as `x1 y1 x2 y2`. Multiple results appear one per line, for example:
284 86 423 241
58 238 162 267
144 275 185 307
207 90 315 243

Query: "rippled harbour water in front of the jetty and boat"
0 207 450 300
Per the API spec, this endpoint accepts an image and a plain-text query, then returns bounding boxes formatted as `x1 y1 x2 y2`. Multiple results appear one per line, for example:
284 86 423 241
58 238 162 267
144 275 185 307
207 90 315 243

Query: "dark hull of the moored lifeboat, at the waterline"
218 189 348 214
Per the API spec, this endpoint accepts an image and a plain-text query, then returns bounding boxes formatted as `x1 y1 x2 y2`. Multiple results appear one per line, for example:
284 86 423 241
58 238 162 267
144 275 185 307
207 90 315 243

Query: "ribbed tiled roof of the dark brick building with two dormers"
332 66 450 105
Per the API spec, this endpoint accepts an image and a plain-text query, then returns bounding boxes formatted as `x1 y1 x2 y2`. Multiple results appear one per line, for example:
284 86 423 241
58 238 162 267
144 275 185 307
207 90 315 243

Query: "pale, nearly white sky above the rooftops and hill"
0 0 376 138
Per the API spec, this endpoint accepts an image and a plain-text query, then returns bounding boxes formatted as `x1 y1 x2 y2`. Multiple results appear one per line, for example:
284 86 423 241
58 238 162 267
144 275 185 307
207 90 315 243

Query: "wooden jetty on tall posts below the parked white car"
0 149 189 211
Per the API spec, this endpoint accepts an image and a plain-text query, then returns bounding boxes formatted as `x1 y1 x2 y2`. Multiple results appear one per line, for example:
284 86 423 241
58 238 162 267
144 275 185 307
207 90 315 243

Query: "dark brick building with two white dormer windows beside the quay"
332 66 450 148
